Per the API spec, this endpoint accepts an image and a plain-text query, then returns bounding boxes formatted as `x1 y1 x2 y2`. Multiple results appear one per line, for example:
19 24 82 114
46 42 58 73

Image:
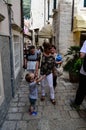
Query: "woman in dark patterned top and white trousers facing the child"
40 42 56 105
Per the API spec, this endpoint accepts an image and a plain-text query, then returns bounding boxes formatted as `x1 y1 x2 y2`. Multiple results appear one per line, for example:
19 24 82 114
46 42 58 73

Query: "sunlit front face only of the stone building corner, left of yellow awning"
59 1 73 54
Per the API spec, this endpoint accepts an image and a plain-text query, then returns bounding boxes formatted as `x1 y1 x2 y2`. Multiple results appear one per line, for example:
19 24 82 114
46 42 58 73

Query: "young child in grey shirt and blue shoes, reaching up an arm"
25 72 45 115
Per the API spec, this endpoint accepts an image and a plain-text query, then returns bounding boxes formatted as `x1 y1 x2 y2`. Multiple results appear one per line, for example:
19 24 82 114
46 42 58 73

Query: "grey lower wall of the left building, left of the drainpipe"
0 36 12 125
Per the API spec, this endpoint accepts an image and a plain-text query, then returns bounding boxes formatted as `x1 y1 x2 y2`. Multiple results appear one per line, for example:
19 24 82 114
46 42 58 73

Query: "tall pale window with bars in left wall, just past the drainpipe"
13 35 20 78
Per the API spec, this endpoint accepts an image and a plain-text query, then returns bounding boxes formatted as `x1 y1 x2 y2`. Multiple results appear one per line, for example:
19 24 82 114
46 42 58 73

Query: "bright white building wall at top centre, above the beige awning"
31 0 53 29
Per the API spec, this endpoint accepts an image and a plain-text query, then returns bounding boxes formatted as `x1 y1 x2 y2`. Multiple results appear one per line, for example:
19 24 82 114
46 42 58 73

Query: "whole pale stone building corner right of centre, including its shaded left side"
53 0 74 55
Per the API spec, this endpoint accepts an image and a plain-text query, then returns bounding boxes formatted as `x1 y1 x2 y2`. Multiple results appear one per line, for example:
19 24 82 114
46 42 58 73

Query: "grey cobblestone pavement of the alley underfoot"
0 71 86 130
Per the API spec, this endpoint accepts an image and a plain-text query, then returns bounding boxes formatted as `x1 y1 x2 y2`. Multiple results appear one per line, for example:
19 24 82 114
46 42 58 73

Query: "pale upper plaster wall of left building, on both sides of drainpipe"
0 0 21 35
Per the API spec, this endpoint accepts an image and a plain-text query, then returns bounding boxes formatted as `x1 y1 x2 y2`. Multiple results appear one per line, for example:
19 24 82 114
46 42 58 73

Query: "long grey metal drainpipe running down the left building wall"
7 4 14 97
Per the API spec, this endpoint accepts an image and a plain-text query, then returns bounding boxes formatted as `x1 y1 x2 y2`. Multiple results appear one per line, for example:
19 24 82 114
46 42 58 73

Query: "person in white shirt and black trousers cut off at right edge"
71 40 86 110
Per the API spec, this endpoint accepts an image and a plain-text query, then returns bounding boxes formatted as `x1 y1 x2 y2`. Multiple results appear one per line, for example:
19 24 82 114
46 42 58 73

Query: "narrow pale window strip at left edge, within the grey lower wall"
0 55 4 105
